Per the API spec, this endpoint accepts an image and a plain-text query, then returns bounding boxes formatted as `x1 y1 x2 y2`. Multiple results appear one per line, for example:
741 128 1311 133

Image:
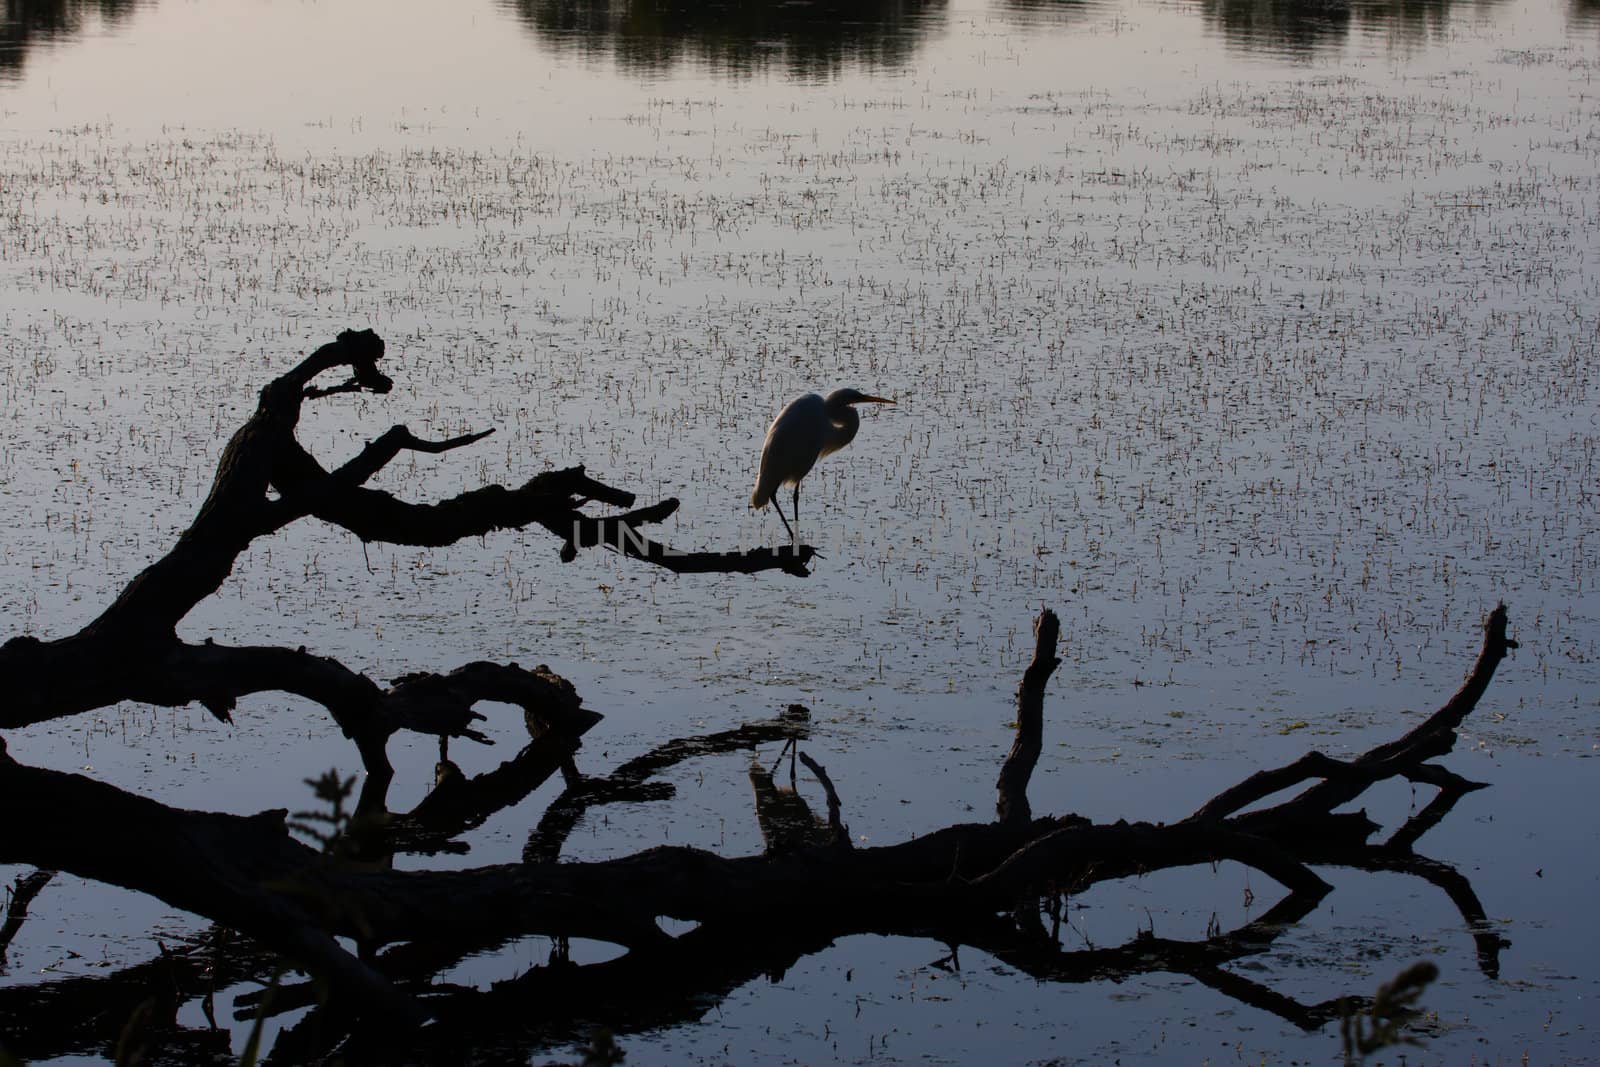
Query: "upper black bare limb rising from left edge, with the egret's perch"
0 330 814 781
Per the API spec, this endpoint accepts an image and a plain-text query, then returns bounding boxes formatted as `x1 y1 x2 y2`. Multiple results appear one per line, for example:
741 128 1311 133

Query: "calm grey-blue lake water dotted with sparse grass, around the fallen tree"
0 0 1600 1064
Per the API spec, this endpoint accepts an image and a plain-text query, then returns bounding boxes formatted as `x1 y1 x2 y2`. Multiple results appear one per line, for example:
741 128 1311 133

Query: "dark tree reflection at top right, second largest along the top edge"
1200 0 1501 59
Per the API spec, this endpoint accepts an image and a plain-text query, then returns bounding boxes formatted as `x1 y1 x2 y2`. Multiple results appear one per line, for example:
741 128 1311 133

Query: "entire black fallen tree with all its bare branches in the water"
0 331 1515 1062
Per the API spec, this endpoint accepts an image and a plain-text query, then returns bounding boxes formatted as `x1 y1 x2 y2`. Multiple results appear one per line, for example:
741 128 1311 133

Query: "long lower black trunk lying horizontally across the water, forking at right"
0 604 1504 1055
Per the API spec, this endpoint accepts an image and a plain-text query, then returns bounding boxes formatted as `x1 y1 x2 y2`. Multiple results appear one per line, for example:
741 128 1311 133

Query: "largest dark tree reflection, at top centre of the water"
501 0 946 80
